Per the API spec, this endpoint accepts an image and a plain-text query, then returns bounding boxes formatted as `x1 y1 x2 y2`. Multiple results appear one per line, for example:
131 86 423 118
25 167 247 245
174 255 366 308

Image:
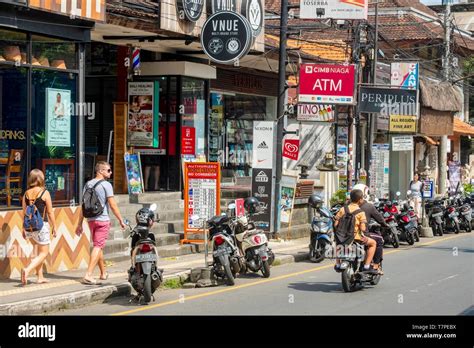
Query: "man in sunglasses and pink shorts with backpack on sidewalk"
76 161 125 285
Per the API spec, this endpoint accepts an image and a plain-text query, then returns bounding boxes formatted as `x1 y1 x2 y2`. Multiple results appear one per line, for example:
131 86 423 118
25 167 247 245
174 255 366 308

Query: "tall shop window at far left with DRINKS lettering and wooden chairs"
0 65 27 209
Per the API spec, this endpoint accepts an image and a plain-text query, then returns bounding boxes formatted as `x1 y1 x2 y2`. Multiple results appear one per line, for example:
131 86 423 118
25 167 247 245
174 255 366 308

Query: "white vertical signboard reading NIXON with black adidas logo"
252 121 275 169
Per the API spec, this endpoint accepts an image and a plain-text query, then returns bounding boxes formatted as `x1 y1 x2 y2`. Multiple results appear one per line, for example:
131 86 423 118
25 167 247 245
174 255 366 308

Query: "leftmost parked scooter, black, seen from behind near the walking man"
125 204 163 304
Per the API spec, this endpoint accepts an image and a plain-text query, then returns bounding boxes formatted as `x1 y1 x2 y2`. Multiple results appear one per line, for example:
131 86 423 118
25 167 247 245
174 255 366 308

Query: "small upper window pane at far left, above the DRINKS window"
0 29 28 64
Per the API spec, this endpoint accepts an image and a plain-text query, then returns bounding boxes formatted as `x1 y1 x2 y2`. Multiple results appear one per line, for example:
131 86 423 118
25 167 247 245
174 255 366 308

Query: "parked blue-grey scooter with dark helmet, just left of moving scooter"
308 194 337 262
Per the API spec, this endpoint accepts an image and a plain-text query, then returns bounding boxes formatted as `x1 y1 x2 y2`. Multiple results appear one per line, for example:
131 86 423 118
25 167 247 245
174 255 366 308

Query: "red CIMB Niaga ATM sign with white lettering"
298 64 355 105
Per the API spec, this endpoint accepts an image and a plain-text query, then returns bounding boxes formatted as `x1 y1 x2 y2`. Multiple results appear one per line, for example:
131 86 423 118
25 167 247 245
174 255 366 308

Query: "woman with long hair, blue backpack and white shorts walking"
21 169 56 285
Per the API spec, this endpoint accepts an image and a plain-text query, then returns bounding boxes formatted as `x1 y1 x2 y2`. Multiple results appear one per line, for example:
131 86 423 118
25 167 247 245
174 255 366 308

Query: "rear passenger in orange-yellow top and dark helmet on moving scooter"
334 190 380 274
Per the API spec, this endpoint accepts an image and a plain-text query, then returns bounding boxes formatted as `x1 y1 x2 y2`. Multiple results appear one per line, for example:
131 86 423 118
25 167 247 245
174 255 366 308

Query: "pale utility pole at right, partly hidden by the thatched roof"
439 0 452 195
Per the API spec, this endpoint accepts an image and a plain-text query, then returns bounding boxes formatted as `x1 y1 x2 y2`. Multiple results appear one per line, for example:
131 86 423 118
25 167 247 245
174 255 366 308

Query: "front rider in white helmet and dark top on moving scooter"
352 184 389 274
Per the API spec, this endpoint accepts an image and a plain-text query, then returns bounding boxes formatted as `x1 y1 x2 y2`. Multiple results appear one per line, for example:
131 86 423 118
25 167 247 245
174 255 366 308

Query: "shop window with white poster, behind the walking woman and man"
31 69 79 205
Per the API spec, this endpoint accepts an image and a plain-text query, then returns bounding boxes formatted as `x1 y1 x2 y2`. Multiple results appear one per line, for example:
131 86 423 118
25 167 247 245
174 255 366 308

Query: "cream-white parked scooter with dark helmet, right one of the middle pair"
229 197 275 278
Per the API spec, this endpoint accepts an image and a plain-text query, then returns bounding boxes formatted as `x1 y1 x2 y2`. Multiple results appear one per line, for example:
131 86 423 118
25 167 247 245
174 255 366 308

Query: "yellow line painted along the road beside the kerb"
110 235 465 316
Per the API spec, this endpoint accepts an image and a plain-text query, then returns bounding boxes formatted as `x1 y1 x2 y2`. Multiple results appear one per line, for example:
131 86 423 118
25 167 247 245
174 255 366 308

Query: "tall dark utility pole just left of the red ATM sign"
273 0 288 237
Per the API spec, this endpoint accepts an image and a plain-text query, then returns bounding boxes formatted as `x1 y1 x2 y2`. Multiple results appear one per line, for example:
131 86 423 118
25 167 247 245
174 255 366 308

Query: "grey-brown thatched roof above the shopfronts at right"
420 77 462 112
